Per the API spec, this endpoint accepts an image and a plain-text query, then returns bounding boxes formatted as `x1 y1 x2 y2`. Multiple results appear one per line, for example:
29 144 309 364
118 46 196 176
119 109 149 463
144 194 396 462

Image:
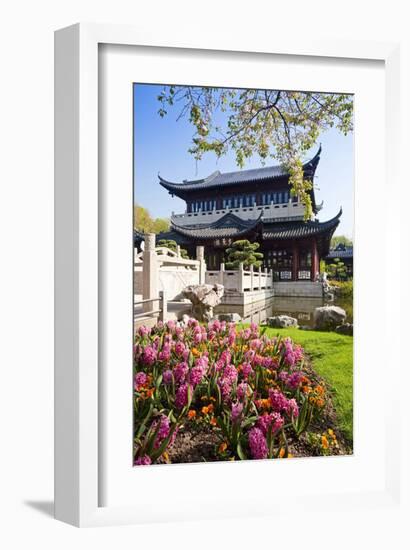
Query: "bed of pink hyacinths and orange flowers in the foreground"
134 319 338 465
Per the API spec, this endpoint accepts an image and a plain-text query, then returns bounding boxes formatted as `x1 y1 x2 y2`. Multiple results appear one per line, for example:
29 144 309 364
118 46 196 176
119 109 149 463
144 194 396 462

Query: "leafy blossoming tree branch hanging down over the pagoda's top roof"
158 86 353 219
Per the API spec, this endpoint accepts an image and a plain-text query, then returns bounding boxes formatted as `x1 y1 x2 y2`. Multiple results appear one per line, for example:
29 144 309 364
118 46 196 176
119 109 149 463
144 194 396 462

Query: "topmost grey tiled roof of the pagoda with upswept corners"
158 146 322 194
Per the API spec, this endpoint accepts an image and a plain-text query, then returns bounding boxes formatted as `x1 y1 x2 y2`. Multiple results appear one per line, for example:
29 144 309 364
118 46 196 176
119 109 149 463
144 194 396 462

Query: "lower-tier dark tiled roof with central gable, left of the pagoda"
171 212 263 239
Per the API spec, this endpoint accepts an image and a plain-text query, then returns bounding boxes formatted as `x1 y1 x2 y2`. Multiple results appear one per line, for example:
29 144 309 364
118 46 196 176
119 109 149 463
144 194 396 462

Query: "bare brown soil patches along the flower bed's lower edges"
159 361 353 464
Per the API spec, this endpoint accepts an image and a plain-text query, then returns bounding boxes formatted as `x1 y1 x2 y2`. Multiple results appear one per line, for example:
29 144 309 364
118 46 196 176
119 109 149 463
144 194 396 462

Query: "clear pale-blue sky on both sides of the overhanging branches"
134 84 353 238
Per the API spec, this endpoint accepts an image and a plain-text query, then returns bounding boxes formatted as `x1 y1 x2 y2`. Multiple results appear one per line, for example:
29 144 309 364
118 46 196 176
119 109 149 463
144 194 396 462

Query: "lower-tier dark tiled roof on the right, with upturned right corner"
262 209 342 240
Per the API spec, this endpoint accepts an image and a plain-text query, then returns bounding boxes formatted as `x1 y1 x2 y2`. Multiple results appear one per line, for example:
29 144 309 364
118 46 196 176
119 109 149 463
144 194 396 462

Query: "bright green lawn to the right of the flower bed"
266 328 353 444
